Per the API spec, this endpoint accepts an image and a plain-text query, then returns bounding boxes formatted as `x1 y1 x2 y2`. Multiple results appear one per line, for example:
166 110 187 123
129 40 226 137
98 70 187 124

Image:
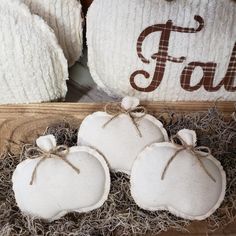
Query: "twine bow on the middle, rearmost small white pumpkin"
103 103 147 137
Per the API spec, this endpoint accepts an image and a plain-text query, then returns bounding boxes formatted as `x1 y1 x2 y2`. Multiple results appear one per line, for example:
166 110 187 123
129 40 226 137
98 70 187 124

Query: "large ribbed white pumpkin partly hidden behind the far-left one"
21 0 84 66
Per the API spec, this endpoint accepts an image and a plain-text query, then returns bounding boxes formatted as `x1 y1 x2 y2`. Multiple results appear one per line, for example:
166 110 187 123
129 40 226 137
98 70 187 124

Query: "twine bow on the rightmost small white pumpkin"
161 135 216 182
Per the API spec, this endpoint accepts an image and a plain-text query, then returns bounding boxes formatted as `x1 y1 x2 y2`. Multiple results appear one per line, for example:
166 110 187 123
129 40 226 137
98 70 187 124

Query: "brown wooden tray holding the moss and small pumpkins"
0 102 236 236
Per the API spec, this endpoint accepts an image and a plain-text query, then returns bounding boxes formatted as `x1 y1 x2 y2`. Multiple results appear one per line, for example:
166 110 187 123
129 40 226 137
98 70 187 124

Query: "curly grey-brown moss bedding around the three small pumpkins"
0 108 236 236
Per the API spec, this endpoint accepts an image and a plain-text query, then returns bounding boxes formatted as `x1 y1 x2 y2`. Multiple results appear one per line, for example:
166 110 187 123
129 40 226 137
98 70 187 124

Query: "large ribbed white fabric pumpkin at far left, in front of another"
0 0 68 104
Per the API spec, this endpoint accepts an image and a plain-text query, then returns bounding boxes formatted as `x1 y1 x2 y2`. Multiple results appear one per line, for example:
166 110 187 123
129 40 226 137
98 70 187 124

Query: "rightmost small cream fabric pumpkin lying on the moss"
130 130 226 220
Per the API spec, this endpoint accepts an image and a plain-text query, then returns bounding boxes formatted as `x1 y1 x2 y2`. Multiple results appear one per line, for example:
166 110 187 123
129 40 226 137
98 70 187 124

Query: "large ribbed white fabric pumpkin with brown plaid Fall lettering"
87 0 236 101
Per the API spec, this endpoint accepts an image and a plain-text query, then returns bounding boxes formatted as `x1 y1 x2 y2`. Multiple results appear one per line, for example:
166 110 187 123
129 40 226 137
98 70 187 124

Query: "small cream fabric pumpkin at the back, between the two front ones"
78 97 168 174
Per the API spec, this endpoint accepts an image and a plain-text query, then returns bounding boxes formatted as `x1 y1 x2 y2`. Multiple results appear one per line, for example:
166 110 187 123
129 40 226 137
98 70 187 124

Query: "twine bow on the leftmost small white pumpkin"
26 145 80 185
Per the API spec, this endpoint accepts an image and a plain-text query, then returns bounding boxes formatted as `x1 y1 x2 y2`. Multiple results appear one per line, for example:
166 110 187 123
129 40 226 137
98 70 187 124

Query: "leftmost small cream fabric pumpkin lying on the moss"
12 135 110 221
